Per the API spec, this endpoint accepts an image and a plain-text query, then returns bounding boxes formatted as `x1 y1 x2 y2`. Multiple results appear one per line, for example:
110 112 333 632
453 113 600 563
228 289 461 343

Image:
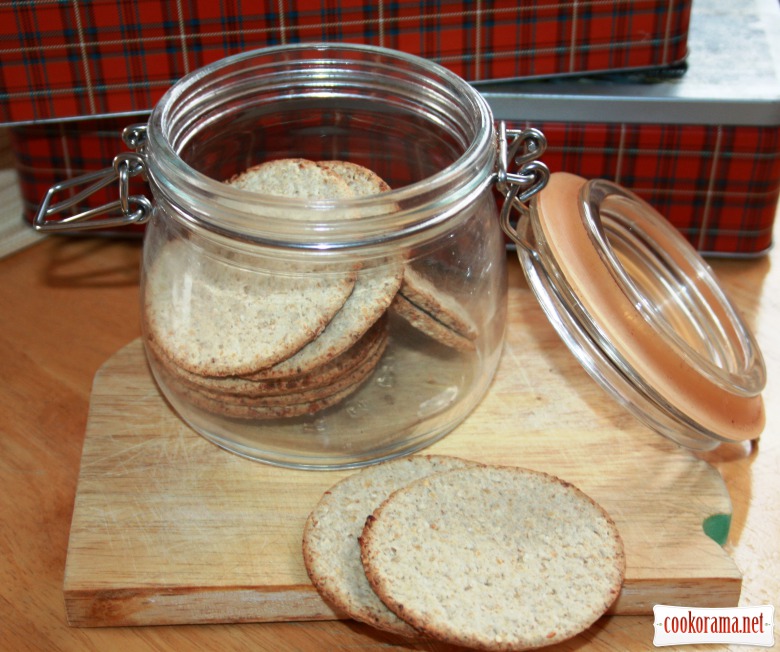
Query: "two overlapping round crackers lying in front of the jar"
303 455 625 650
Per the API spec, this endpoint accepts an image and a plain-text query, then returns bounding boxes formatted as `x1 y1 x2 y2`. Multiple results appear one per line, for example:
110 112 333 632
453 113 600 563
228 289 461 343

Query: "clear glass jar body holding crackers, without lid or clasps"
131 45 506 468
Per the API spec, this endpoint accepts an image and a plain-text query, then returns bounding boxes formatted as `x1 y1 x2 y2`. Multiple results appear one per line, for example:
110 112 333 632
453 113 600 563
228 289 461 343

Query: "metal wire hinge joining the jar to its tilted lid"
496 121 550 249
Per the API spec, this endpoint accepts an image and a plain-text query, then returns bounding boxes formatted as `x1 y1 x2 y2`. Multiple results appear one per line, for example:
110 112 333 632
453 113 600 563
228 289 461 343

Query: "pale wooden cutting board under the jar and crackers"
64 266 741 626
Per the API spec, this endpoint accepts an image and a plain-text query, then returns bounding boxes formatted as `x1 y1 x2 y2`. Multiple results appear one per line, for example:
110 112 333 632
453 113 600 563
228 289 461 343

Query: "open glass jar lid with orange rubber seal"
513 173 766 449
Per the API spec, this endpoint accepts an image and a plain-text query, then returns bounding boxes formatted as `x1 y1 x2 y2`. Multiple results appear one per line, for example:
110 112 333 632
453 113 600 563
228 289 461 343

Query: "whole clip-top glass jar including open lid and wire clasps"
36 44 766 469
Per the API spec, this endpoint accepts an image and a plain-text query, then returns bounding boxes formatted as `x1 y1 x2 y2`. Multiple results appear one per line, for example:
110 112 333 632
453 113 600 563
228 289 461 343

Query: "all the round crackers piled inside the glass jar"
144 159 477 419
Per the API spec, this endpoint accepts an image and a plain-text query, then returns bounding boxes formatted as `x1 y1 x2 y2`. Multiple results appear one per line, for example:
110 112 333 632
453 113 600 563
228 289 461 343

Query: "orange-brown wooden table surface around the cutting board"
0 136 780 651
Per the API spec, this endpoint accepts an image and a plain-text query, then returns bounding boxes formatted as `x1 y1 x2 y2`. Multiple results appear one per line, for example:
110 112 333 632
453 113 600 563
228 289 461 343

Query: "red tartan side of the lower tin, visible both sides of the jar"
11 118 780 255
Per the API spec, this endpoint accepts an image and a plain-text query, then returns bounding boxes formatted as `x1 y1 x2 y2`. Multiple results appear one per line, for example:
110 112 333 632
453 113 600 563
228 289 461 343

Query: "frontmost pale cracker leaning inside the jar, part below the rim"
144 240 355 376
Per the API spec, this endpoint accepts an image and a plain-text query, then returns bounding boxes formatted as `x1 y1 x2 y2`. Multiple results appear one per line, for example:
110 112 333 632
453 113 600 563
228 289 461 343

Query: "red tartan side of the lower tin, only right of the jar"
515 122 780 255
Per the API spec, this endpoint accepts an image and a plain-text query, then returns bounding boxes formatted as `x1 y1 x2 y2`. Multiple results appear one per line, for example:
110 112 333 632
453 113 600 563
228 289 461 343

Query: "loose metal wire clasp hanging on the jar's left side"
33 124 152 232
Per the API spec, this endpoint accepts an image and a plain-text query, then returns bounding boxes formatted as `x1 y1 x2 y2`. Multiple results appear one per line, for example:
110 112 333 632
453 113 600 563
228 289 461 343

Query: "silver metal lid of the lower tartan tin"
478 0 780 126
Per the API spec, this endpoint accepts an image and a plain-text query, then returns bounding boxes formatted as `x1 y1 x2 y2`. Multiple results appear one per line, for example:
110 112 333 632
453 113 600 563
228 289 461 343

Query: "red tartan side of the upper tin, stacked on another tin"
0 0 692 123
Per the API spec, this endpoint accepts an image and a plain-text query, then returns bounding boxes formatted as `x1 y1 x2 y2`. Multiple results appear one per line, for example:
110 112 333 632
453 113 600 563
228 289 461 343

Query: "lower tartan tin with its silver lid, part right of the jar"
481 0 780 256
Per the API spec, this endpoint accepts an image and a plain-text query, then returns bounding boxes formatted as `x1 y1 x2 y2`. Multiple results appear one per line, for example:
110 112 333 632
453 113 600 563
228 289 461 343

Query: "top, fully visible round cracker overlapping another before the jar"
361 467 625 650
